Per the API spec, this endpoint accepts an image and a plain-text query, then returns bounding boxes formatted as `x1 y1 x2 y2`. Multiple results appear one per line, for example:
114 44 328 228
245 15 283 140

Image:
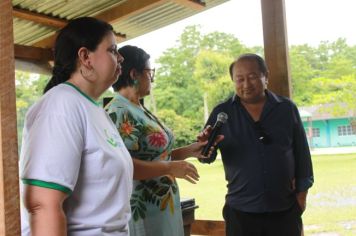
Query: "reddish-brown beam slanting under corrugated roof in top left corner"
13 7 68 28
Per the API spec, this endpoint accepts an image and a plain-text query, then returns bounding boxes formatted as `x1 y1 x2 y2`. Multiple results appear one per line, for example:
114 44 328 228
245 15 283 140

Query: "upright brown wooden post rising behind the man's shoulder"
261 0 292 97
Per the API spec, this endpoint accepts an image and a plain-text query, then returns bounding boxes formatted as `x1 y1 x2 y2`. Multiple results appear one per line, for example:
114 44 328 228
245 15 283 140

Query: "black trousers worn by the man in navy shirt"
223 202 303 236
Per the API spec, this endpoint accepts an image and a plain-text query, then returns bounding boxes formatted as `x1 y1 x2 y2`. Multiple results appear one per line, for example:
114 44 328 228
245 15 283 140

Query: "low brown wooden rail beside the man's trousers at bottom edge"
191 220 225 236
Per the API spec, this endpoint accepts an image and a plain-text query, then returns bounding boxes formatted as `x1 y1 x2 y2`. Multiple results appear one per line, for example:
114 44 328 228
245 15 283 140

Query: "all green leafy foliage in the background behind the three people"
16 26 356 146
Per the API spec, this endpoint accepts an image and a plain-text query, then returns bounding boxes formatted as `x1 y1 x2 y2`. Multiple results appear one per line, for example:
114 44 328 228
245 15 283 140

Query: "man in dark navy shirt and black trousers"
200 54 314 236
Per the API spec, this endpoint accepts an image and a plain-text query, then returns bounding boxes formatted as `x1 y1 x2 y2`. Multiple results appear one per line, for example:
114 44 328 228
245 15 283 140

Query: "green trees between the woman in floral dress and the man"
154 26 254 145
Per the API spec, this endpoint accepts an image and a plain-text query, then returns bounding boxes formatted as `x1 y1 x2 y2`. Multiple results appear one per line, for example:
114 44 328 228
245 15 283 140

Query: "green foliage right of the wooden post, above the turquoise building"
290 39 356 119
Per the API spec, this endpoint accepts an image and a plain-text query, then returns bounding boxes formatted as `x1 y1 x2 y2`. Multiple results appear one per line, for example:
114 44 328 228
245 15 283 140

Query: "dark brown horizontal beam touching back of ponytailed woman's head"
14 44 54 61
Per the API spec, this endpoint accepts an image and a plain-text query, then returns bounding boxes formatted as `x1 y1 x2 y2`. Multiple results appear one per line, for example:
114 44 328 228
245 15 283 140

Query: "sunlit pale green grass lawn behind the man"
178 154 356 236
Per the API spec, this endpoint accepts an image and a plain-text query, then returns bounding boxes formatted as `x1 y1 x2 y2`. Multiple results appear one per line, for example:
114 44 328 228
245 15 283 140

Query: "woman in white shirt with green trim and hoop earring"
20 17 133 236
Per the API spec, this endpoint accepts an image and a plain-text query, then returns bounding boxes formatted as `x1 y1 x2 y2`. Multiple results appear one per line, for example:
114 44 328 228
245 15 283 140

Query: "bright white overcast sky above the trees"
118 0 356 62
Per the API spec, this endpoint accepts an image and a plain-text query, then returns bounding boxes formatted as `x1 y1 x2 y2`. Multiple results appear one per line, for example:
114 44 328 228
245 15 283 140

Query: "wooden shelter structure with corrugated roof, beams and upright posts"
0 0 290 236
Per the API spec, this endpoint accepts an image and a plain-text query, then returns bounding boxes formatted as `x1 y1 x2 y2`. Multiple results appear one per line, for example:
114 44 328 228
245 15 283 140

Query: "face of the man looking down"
232 59 267 103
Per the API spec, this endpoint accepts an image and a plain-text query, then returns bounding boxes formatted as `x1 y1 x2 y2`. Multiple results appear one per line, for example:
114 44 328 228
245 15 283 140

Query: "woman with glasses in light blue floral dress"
106 46 214 236
